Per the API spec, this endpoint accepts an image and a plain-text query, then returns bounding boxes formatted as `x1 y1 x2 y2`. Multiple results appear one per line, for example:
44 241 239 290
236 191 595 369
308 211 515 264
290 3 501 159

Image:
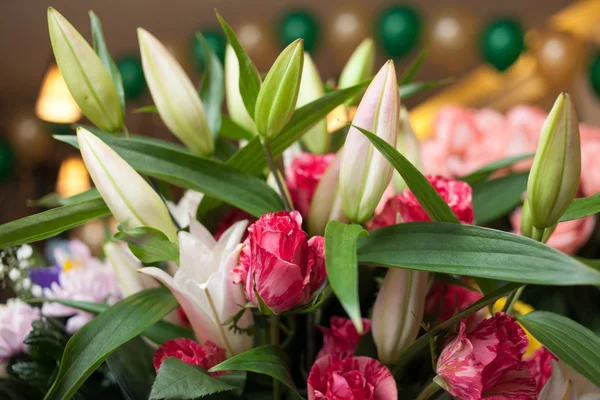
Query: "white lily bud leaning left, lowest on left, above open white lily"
77 127 177 243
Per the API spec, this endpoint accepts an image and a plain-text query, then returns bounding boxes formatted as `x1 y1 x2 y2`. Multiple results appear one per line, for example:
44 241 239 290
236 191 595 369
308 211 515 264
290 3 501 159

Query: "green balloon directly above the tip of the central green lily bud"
279 11 320 53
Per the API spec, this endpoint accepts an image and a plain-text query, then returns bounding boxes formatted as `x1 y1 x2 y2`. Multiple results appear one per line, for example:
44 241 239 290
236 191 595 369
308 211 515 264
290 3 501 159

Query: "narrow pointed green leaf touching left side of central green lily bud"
215 11 260 117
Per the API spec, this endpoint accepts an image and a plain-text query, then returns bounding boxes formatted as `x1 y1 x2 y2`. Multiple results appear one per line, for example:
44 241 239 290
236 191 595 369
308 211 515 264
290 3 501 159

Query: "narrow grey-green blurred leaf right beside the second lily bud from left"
196 32 225 138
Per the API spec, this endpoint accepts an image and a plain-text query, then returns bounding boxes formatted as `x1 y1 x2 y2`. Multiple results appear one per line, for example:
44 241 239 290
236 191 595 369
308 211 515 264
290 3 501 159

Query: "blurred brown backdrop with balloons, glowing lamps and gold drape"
0 0 600 266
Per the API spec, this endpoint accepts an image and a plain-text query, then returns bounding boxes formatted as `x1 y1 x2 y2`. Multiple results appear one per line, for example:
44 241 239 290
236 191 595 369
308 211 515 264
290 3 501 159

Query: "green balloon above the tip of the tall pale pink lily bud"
377 6 422 58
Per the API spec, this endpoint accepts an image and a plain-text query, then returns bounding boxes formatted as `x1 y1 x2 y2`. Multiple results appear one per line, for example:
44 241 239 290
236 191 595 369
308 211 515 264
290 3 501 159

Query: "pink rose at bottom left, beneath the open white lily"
152 338 225 376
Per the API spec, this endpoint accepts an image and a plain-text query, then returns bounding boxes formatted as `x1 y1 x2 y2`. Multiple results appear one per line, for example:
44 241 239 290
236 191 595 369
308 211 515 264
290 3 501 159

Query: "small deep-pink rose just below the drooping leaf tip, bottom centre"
317 317 371 359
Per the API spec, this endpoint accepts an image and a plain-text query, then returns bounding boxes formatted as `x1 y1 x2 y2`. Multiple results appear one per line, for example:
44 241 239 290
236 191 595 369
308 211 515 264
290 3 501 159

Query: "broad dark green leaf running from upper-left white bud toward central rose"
56 130 283 217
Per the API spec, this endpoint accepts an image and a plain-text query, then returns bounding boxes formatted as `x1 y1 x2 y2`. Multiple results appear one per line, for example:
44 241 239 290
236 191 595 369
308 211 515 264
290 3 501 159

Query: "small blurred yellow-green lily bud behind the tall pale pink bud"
338 38 375 106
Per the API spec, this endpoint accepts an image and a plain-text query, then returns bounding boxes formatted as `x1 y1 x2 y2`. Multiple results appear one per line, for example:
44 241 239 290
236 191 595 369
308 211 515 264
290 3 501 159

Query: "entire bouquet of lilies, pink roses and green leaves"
0 8 600 400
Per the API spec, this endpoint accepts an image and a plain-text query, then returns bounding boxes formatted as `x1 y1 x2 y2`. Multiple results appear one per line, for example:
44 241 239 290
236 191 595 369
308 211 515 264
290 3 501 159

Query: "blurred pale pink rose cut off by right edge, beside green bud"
580 125 600 196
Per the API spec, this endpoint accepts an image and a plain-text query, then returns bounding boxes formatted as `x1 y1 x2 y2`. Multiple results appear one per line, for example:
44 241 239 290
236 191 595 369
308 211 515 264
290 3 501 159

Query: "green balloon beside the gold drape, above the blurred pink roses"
481 18 525 71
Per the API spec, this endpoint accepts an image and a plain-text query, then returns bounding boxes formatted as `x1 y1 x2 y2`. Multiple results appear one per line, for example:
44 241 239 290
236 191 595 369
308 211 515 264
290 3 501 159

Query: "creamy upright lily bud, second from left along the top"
138 28 214 156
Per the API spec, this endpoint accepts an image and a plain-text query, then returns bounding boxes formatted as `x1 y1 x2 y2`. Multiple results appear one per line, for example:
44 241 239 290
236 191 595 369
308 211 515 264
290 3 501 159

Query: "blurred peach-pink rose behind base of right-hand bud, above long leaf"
510 208 596 255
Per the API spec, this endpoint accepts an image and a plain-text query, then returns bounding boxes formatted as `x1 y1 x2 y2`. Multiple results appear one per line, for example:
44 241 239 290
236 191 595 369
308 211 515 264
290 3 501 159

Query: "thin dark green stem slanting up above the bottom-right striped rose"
393 283 521 374
